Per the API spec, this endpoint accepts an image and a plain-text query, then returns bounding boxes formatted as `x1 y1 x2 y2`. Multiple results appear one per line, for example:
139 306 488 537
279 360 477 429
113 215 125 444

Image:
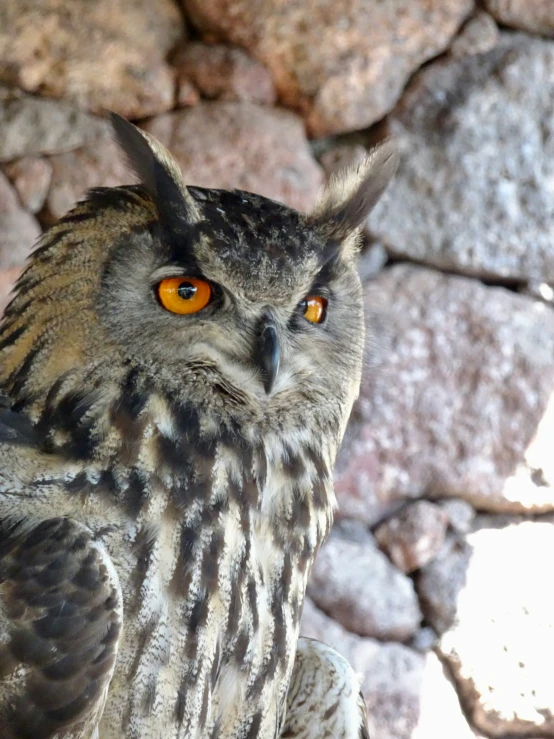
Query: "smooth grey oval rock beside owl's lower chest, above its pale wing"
308 534 421 641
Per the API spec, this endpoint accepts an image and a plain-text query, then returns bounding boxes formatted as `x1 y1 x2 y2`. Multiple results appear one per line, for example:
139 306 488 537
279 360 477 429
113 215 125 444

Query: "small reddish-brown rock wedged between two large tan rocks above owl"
173 42 276 105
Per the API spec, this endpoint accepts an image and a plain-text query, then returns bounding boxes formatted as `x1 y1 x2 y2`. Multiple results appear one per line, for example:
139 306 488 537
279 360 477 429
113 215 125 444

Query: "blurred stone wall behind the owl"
0 0 554 739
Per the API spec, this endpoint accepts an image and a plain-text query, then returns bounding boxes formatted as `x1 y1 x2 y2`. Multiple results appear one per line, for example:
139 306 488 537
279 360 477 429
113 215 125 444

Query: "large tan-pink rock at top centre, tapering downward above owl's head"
184 0 474 136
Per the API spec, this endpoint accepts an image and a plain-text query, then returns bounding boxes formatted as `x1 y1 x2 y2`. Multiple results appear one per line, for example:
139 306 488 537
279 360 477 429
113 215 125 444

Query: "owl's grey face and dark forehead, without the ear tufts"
97 188 363 416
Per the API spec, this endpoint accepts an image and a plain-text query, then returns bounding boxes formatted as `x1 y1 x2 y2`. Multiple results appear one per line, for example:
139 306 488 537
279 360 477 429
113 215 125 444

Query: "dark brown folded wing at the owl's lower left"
0 518 122 739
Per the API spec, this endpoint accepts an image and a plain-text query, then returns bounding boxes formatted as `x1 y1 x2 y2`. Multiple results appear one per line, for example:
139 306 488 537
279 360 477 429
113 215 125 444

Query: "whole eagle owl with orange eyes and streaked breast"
0 116 396 739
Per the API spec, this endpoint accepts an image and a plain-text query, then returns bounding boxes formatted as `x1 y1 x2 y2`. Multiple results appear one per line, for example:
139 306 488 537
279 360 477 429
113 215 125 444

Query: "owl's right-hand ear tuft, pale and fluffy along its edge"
309 140 399 240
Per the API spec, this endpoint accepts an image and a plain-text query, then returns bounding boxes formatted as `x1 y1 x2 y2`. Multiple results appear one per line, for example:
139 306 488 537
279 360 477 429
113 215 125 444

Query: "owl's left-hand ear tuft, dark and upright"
110 113 201 228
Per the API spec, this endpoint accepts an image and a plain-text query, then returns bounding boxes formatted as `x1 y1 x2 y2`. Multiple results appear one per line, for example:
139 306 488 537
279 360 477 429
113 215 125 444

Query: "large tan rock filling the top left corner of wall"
0 0 184 118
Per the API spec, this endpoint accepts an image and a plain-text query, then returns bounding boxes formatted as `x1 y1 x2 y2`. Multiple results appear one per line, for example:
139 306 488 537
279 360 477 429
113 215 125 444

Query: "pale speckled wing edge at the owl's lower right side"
280 637 369 739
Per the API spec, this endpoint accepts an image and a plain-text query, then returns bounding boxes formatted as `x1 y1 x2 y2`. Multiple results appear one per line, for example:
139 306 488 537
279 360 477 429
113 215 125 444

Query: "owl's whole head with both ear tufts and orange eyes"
0 116 397 450
